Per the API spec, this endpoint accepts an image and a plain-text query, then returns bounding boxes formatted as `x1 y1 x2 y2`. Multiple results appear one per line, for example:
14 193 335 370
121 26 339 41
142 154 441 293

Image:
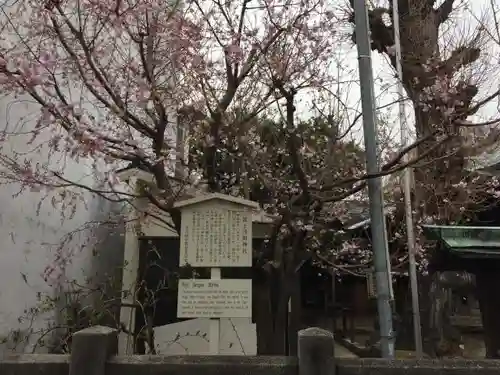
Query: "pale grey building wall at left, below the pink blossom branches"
0 96 124 354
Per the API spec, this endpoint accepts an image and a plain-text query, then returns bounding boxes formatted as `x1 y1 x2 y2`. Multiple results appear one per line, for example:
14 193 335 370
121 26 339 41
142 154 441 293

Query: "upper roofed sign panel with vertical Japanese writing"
180 206 252 267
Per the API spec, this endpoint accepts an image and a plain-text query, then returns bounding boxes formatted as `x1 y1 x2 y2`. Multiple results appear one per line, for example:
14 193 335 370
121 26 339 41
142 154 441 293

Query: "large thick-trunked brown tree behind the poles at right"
350 0 500 356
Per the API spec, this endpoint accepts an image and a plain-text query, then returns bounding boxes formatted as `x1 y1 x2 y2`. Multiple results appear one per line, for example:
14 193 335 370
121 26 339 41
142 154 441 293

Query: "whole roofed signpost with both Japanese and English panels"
174 193 259 354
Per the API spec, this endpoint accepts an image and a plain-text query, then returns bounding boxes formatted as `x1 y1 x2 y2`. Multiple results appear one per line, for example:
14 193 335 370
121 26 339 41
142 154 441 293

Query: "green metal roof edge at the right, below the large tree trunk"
422 225 500 258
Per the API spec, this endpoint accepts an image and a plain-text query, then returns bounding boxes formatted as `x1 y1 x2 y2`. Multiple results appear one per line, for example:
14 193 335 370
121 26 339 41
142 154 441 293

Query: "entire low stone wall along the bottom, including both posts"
0 326 500 375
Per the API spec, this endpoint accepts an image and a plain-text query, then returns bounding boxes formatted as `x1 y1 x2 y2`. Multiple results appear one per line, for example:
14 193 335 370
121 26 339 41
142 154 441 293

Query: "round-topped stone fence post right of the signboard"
298 327 336 375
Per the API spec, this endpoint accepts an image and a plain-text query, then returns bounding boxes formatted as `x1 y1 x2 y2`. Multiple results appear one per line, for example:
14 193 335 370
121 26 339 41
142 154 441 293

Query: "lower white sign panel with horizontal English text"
177 279 252 318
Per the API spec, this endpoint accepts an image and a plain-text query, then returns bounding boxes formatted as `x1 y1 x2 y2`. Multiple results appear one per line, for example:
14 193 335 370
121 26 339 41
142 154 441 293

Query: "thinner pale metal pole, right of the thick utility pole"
392 0 423 358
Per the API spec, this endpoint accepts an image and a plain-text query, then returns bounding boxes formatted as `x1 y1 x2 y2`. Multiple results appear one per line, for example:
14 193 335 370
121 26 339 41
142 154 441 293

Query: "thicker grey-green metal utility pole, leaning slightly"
354 0 394 358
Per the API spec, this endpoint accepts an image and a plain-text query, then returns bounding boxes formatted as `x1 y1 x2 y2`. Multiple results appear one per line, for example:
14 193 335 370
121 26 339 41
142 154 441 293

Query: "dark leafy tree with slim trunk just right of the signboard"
188 93 438 354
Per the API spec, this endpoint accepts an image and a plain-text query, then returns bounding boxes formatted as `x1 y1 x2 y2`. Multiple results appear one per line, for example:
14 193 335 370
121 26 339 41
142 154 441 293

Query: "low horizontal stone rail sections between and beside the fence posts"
0 354 500 375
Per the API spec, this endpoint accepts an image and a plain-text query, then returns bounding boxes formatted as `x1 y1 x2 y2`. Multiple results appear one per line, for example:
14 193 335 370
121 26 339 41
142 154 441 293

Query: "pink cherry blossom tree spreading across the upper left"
0 0 348 356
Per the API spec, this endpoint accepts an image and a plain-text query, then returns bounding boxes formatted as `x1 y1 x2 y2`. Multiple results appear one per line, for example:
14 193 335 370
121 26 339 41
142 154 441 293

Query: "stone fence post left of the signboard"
69 326 118 375
